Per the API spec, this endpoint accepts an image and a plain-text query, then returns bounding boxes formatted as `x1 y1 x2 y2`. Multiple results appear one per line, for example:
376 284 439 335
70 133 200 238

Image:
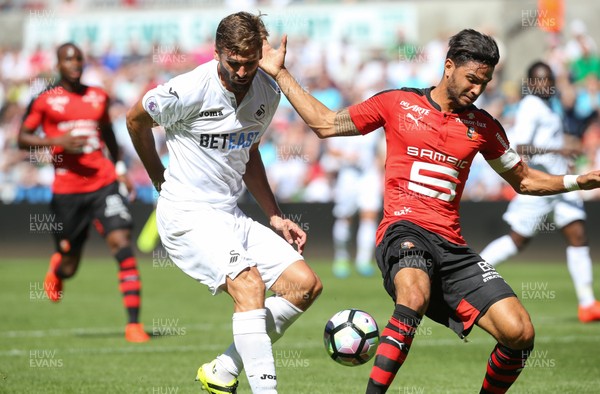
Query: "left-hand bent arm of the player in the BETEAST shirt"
126 100 165 191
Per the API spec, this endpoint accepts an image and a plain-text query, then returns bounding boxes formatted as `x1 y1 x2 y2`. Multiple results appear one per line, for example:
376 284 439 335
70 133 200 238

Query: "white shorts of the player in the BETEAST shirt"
156 198 304 295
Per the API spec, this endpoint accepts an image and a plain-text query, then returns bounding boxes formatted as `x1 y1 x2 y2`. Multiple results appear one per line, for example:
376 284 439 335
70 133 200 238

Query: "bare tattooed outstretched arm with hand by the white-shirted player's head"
260 35 360 138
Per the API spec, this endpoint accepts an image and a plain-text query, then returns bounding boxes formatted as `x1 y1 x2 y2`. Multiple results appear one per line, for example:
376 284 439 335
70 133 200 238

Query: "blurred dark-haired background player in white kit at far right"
481 62 600 323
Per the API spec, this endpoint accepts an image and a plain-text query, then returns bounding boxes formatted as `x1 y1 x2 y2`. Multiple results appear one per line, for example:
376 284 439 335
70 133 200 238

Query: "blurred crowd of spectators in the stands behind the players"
0 16 600 204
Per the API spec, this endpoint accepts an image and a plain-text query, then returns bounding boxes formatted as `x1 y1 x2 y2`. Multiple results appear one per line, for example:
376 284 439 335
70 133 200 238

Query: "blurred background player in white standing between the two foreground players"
326 129 384 278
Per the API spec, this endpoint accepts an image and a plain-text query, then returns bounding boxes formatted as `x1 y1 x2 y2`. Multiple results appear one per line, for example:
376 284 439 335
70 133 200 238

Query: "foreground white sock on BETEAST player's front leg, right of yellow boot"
233 309 277 394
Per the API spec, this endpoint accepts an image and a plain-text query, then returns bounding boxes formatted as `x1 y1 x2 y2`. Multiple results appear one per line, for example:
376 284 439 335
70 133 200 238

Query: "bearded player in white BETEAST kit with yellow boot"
127 12 322 393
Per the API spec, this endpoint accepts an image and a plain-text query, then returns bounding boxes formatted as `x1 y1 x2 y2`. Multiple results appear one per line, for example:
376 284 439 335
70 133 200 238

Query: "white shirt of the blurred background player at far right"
510 95 569 175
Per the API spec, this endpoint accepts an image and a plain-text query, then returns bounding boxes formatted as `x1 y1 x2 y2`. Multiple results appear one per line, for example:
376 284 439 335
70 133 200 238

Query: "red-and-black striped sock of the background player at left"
115 247 142 323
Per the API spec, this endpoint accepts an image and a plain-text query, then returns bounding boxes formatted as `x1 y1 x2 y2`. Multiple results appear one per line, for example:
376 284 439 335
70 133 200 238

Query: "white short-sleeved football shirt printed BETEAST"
142 60 281 210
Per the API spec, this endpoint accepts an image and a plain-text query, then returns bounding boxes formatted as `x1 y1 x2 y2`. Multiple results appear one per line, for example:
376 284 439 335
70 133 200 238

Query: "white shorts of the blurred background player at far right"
502 192 586 238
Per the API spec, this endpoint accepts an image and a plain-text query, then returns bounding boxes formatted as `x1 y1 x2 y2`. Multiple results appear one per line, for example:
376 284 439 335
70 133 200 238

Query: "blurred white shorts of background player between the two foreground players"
333 168 383 218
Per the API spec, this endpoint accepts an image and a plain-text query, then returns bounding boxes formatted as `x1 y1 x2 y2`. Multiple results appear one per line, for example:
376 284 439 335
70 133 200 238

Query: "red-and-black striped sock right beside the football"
367 304 421 394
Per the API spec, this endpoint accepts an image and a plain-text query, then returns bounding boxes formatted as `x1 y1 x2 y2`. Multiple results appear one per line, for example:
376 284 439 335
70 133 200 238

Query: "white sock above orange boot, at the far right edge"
567 246 596 307
